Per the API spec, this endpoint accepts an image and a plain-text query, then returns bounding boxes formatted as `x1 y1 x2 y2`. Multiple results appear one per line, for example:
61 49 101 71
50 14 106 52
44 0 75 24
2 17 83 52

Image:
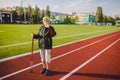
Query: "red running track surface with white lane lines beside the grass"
0 31 120 80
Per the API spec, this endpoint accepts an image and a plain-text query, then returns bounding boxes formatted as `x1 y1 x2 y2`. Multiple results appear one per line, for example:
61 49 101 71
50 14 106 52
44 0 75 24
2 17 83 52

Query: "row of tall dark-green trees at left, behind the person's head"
12 5 50 23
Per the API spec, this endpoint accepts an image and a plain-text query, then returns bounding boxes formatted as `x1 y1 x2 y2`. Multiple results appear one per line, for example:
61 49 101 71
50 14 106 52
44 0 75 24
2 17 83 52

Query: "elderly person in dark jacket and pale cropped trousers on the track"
32 17 56 76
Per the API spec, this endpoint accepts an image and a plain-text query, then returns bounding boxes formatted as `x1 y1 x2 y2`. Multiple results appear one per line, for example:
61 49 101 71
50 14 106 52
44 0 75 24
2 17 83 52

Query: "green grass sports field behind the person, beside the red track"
0 24 120 59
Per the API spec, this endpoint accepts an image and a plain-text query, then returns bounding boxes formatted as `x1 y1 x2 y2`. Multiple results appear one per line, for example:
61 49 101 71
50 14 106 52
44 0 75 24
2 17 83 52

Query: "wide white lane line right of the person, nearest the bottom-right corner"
59 38 120 80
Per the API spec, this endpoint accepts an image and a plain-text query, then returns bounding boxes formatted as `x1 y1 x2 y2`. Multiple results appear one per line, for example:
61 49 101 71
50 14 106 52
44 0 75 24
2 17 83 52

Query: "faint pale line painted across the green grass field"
0 30 114 48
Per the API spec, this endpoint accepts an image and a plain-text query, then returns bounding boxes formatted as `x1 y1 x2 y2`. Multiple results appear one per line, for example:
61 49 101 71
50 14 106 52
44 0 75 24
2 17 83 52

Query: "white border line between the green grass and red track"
0 31 117 63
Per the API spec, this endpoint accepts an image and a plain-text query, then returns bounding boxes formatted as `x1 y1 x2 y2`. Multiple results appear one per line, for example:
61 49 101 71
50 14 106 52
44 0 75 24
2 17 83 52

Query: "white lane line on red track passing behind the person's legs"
1 34 117 80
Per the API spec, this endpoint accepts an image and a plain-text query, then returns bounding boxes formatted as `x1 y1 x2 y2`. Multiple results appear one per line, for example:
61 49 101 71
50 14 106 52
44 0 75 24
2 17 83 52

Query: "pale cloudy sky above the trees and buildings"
0 0 120 17
